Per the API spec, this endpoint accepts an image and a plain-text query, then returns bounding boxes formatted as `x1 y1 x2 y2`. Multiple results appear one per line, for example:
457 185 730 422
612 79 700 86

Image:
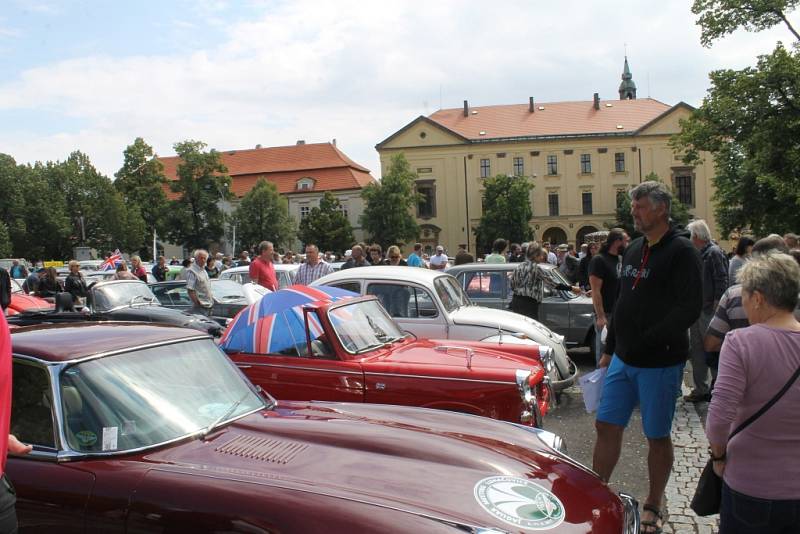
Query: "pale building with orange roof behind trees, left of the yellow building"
159 140 375 253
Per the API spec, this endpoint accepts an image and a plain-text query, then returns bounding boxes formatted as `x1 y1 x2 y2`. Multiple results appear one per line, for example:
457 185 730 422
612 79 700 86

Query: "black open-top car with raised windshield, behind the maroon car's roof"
9 280 222 336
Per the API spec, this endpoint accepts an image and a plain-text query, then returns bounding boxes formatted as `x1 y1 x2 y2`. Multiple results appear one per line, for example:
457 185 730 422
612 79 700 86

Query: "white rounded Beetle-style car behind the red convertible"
311 265 578 392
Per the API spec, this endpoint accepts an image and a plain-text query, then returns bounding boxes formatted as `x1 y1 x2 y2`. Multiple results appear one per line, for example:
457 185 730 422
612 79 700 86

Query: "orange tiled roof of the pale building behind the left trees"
159 143 375 197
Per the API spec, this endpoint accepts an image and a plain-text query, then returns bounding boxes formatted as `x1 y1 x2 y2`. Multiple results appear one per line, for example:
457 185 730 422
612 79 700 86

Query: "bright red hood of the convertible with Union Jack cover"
372 339 538 376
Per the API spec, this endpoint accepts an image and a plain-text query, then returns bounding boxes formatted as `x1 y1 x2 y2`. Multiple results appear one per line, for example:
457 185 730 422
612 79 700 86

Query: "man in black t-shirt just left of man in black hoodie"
589 228 630 363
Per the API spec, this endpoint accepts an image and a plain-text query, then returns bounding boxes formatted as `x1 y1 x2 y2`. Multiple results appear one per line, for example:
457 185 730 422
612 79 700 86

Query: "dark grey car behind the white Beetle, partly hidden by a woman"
446 263 595 347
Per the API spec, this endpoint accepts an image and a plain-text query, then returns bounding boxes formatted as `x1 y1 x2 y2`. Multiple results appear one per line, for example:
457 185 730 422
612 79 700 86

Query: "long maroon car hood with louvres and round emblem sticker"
148 402 624 532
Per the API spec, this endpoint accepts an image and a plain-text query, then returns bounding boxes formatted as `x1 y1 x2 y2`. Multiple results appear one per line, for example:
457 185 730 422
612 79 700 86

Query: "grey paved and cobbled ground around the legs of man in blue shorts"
544 349 718 534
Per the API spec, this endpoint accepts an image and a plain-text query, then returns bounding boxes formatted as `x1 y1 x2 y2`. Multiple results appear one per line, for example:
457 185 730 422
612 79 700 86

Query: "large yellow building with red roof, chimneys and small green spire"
376 58 715 252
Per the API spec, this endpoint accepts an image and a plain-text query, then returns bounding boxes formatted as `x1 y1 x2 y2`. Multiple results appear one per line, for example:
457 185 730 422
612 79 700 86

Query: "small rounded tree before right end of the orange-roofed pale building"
298 191 355 252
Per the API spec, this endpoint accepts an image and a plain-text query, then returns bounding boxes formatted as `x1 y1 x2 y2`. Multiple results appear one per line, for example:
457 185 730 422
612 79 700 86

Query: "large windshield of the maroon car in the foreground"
60 339 264 452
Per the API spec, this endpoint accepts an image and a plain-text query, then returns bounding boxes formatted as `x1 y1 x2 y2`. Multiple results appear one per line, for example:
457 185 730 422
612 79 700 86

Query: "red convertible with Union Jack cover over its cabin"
220 286 554 427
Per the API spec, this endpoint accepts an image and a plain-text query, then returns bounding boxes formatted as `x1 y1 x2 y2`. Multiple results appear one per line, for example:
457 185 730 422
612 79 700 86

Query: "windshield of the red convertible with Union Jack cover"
328 300 405 354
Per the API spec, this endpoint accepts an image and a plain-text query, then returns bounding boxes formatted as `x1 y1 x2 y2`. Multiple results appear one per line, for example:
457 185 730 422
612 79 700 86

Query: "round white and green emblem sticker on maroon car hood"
474 476 565 530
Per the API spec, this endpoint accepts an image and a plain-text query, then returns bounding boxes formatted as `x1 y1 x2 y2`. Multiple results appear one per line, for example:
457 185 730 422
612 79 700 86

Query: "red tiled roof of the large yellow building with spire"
424 98 671 142
